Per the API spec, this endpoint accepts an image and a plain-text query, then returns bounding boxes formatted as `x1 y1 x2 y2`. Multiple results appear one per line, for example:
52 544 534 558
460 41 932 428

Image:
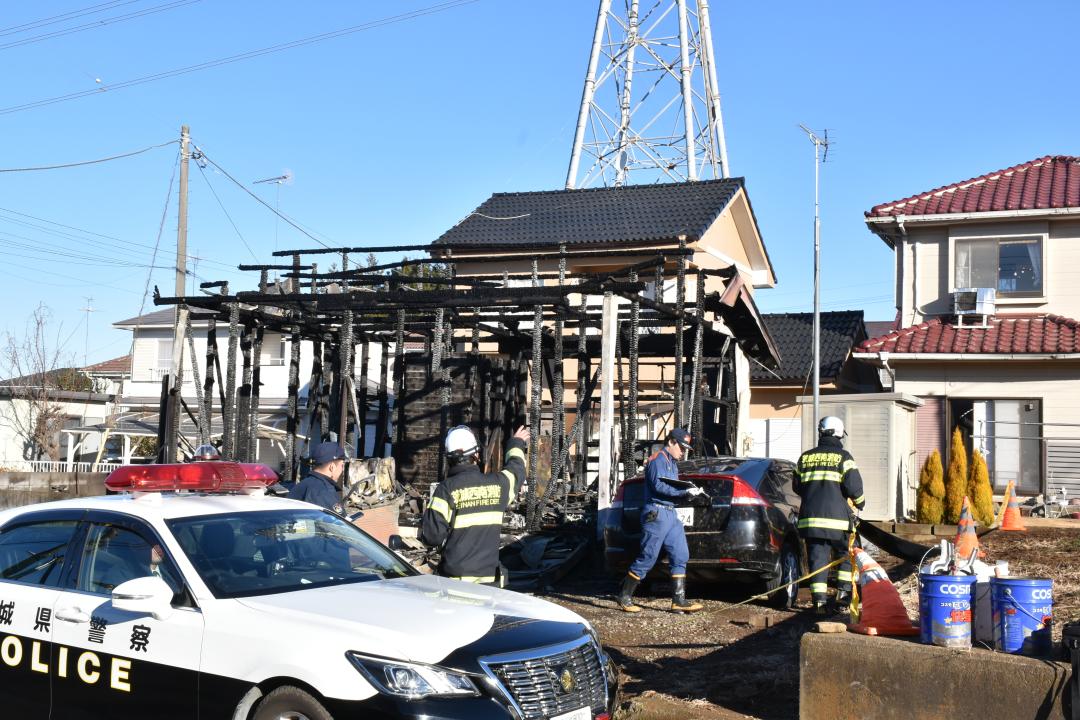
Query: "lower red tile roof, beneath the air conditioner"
855 315 1080 355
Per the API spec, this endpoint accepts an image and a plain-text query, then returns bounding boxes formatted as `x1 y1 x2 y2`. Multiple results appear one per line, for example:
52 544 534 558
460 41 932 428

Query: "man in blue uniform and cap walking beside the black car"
618 427 703 613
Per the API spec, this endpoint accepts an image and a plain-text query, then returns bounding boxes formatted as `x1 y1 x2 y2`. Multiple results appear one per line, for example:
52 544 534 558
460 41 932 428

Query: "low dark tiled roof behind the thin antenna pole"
751 310 866 386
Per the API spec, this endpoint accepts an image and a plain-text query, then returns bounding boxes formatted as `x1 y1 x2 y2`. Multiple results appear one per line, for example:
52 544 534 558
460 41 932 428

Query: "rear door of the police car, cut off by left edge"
0 513 81 719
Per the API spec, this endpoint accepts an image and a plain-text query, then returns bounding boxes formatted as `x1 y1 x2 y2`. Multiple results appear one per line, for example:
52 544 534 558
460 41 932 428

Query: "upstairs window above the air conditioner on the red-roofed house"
955 236 1042 297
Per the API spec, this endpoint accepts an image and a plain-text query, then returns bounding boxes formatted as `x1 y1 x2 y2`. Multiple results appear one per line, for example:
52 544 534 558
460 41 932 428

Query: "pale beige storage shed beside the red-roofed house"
797 393 922 520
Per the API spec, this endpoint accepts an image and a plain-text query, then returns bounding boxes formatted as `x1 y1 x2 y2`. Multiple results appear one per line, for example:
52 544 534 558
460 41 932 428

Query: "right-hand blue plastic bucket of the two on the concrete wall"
990 578 1054 655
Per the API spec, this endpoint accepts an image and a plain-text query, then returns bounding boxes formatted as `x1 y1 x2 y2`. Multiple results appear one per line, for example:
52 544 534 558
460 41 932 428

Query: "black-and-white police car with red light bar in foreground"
0 462 616 720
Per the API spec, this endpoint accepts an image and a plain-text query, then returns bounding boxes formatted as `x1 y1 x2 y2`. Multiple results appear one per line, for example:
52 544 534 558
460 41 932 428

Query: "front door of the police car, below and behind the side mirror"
53 513 203 720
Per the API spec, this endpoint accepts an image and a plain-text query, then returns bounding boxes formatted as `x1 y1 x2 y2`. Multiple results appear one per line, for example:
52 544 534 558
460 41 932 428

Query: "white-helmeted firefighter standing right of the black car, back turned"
793 416 864 614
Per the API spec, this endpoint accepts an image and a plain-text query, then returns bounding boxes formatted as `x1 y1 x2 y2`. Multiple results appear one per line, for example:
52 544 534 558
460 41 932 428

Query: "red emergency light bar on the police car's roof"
105 462 278 492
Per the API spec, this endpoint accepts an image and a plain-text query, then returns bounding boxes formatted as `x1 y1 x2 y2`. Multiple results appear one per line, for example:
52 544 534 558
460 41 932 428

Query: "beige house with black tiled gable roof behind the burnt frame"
430 178 778 462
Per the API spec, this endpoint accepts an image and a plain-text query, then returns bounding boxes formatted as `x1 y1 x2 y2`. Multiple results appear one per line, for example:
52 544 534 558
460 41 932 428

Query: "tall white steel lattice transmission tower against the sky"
566 0 728 189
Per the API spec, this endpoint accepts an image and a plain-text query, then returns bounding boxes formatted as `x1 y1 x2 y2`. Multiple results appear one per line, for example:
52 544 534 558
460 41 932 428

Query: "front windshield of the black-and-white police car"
167 510 415 598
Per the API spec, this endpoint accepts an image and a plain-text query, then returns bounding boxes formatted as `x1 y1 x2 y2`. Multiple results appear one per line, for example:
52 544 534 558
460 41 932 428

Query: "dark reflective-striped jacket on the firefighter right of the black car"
793 435 864 540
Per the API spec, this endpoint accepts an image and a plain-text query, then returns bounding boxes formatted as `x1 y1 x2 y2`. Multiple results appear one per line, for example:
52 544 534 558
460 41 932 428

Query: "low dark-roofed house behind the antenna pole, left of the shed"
746 310 880 460
